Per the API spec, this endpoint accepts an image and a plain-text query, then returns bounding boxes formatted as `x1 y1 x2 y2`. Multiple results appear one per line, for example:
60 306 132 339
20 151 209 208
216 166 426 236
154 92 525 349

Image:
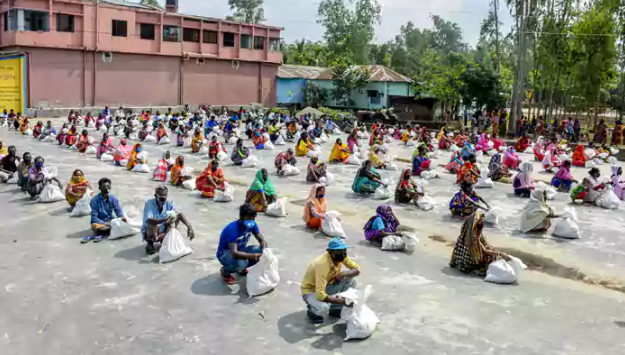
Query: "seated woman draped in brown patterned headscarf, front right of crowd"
449 212 510 276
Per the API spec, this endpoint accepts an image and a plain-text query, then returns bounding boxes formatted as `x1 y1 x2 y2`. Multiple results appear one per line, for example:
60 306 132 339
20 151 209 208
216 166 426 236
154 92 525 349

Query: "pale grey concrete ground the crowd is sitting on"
0 121 625 355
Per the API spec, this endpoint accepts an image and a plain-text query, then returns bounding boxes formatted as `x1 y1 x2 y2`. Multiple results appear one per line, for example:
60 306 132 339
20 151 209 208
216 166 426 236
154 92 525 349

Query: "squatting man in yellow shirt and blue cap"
302 238 360 323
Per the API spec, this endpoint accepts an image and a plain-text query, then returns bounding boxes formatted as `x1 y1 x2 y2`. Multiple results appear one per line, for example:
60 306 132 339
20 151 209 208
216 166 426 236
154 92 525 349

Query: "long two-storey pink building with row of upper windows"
0 0 282 108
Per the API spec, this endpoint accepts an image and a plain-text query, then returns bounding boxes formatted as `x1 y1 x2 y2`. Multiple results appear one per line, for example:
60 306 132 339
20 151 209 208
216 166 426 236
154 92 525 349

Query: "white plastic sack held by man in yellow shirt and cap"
337 285 380 340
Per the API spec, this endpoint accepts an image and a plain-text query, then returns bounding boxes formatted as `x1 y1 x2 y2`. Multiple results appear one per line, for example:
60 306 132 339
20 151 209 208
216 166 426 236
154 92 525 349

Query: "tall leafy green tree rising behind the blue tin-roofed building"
318 0 381 64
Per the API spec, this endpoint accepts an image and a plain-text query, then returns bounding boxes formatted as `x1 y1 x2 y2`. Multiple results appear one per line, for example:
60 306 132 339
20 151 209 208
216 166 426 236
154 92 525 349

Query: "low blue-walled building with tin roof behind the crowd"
277 65 414 110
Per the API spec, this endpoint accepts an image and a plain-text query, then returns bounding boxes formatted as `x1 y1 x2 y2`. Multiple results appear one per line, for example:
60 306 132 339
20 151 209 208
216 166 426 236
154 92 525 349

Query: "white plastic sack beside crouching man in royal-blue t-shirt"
246 248 280 297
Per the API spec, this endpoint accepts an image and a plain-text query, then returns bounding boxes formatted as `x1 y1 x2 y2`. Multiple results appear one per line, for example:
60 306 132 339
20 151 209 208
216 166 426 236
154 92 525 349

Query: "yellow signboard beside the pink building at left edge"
0 56 26 112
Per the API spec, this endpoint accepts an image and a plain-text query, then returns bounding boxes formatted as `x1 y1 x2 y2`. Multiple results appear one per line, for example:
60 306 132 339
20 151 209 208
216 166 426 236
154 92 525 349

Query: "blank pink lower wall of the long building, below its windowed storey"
22 48 278 108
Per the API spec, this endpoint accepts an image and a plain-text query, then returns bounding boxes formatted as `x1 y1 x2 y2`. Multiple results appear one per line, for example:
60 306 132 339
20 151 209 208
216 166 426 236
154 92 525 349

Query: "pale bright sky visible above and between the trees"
162 0 513 46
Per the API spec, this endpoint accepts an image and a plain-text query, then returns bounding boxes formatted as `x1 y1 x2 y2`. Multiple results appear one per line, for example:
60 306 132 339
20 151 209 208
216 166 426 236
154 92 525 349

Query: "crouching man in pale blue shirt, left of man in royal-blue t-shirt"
141 185 195 254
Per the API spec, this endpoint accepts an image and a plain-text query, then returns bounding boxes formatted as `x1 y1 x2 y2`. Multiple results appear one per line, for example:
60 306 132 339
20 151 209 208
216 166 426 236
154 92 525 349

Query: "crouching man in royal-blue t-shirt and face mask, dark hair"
217 203 267 285
